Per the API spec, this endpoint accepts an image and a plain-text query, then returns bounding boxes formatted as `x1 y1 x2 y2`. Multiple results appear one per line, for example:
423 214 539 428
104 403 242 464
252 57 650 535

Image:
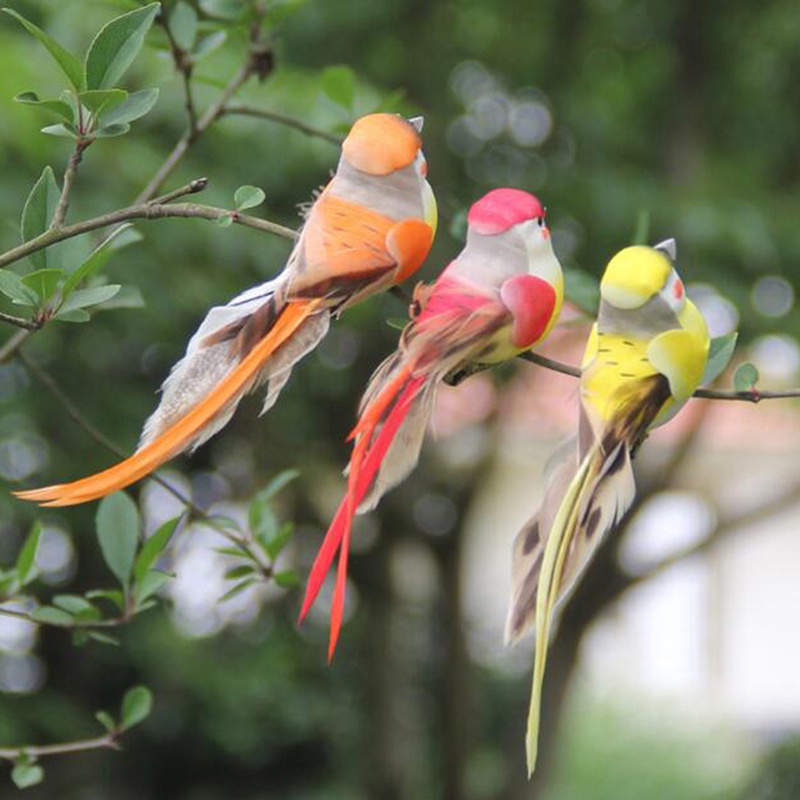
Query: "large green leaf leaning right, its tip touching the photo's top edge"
86 3 161 89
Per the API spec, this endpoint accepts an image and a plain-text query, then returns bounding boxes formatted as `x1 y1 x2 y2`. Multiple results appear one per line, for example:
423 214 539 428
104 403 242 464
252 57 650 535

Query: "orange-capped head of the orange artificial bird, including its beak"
342 114 426 178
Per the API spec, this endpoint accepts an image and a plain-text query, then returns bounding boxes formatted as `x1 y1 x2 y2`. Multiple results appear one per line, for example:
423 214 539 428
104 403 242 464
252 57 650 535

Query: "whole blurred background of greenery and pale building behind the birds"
0 0 800 800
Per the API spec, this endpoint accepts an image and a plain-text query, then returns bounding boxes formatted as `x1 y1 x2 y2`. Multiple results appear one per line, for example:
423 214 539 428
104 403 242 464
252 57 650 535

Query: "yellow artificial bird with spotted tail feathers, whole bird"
506 239 709 775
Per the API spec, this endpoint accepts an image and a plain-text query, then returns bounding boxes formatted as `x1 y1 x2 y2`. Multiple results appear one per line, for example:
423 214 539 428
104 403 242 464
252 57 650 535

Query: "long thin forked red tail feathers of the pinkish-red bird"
300 370 424 660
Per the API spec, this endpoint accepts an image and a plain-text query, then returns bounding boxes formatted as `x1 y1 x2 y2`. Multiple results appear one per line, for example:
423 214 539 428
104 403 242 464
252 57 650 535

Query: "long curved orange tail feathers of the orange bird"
14 300 320 506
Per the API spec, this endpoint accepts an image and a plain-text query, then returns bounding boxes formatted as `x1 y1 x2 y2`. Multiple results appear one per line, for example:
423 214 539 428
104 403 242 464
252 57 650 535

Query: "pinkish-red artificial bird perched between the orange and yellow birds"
300 189 563 658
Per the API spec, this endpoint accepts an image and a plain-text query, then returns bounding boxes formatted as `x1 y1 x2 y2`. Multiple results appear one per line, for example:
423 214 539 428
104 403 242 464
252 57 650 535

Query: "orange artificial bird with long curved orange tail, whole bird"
15 114 436 506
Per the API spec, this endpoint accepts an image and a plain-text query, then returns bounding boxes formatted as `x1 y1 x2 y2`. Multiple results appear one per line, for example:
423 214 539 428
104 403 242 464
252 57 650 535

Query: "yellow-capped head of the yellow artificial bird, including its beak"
600 245 685 313
